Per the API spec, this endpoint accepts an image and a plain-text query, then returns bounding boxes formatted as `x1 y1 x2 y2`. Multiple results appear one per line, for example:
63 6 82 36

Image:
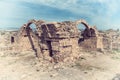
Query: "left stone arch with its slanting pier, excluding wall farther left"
25 19 44 57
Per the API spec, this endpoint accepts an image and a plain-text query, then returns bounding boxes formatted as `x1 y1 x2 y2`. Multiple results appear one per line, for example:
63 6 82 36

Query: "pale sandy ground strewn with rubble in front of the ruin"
0 31 120 80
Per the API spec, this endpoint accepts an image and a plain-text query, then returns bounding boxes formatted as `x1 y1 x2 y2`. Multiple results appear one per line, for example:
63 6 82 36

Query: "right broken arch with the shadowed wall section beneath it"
76 20 103 50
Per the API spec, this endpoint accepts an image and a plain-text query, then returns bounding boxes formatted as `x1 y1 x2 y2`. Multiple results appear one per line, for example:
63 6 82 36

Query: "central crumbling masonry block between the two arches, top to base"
41 21 80 62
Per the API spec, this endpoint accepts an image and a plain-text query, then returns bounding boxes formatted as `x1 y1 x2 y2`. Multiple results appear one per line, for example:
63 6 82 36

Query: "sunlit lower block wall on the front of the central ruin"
52 38 80 61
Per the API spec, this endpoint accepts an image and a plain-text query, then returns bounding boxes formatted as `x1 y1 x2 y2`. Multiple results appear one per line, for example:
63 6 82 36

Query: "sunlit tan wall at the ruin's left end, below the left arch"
12 27 39 51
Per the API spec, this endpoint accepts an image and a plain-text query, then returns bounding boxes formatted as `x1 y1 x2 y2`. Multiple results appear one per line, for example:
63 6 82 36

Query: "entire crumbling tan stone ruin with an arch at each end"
11 20 103 62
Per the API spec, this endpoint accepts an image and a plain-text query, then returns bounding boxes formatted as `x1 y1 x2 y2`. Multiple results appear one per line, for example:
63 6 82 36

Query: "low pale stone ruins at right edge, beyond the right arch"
100 29 120 50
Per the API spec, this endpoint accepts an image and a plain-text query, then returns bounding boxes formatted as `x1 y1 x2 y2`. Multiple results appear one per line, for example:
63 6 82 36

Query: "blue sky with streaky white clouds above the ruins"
0 0 120 29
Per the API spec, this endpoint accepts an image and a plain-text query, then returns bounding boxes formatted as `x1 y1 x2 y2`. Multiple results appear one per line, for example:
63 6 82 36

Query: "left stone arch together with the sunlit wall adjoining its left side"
16 19 44 57
